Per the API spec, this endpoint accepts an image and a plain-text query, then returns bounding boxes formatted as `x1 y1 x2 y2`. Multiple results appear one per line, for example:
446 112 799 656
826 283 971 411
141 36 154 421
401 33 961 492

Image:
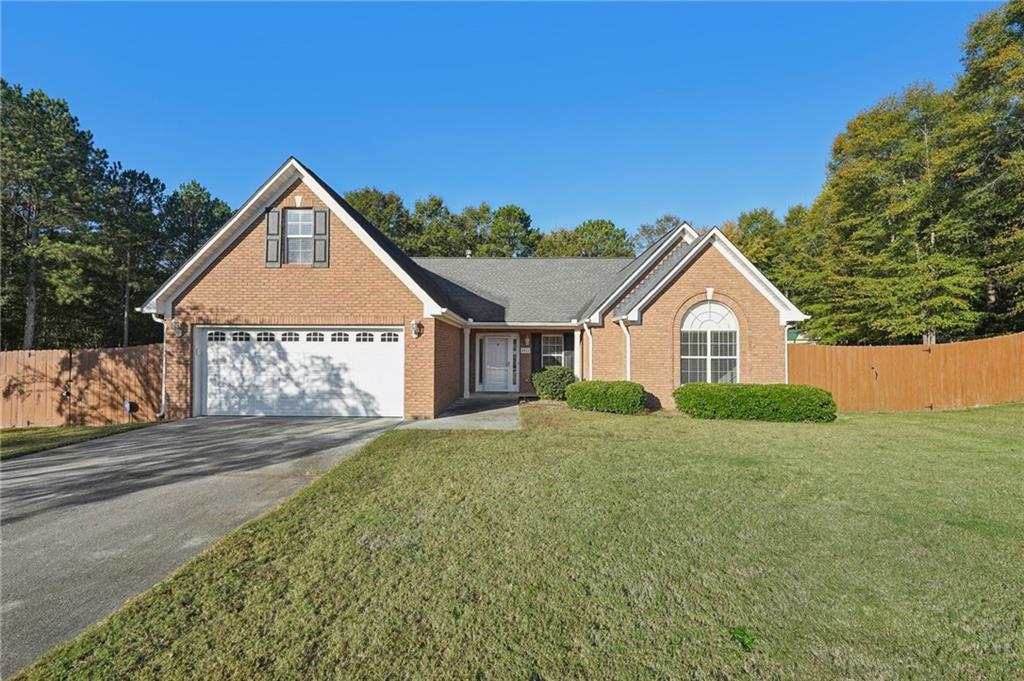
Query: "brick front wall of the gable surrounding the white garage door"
167 182 451 418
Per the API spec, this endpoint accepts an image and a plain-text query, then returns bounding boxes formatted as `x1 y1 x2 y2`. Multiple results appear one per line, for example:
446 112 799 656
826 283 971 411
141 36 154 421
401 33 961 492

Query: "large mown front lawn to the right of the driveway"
16 405 1024 679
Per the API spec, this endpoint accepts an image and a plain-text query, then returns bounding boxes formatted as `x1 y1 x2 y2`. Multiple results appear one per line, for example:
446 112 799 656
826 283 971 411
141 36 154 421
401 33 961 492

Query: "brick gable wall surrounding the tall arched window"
584 240 785 409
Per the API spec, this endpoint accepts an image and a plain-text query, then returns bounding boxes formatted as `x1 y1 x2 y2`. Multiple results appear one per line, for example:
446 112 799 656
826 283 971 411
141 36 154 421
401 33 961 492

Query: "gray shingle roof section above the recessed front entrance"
413 258 635 324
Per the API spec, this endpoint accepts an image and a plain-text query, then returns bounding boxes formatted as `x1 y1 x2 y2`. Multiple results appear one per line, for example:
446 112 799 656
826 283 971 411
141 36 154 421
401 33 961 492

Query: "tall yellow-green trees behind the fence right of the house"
722 0 1024 343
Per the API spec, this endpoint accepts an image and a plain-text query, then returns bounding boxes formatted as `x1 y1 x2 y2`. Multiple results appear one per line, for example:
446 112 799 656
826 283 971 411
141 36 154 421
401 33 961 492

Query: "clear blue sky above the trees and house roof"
0 2 994 235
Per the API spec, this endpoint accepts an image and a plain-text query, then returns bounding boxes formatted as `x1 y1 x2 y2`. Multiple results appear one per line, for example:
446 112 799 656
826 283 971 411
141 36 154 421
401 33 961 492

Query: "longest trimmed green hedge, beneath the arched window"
672 383 836 422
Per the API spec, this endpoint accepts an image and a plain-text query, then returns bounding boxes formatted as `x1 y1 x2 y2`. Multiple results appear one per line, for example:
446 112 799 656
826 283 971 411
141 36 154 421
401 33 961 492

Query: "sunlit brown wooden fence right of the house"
788 333 1024 412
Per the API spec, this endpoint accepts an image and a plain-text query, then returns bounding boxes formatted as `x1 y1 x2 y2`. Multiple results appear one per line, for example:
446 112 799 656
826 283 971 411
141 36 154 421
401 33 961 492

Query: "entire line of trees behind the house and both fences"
0 0 1024 349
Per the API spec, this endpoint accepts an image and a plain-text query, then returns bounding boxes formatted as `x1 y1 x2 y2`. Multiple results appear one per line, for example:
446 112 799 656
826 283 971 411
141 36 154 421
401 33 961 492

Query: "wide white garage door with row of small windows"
196 327 406 416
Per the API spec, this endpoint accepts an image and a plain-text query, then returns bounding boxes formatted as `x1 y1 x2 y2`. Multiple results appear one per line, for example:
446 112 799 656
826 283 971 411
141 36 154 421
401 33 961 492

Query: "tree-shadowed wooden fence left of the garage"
0 343 162 428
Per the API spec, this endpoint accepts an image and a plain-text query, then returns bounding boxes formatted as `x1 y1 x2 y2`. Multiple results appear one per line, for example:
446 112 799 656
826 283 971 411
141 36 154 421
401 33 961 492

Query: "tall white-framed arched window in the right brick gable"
679 300 739 383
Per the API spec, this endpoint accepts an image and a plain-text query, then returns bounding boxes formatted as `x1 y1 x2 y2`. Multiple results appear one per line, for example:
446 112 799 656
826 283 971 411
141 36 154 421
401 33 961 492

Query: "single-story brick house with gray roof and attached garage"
139 159 805 419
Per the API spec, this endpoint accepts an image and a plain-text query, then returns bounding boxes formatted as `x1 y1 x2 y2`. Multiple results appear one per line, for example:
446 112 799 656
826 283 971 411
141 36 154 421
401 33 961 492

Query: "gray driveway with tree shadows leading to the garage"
0 418 399 677
